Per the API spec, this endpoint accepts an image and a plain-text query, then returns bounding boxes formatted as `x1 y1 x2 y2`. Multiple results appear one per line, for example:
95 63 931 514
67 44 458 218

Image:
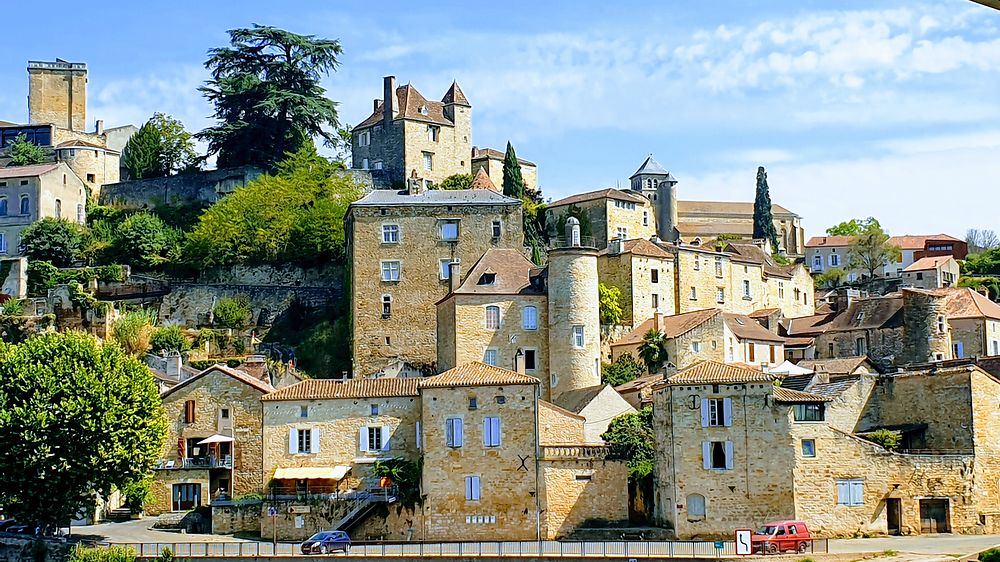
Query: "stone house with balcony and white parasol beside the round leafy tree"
146 365 274 515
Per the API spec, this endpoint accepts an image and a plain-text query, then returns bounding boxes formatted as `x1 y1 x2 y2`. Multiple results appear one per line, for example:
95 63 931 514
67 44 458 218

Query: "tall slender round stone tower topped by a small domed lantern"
547 217 601 400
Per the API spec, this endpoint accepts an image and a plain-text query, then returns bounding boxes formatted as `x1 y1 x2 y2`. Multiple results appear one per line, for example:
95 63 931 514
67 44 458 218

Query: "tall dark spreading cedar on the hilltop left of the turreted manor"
196 25 342 169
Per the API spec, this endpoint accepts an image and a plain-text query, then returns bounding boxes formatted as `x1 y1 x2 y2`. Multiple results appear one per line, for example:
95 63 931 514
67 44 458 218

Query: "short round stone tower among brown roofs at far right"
896 289 952 364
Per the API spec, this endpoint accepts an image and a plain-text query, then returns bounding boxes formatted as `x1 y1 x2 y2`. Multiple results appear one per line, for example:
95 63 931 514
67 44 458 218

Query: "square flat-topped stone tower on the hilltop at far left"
28 59 87 132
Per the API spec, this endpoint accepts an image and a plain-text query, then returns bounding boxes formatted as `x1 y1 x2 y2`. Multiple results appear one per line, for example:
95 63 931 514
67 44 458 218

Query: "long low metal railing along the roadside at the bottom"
101 539 829 559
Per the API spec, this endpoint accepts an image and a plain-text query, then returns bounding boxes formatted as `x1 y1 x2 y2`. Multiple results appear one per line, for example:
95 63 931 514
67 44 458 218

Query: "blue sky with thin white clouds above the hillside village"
0 0 1000 237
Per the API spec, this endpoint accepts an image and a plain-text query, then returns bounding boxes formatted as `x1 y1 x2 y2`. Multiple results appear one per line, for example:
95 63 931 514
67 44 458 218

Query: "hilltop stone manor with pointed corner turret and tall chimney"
351 76 472 188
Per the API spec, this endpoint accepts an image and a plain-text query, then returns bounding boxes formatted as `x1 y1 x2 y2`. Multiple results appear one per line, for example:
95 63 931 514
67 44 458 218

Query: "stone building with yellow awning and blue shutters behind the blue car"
262 362 627 540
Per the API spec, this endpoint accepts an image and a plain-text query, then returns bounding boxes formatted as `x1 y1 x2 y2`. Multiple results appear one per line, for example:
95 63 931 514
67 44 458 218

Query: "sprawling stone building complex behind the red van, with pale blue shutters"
654 362 1000 539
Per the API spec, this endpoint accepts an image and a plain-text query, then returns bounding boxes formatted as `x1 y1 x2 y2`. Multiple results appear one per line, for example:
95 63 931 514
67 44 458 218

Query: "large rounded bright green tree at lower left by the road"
0 331 166 525
